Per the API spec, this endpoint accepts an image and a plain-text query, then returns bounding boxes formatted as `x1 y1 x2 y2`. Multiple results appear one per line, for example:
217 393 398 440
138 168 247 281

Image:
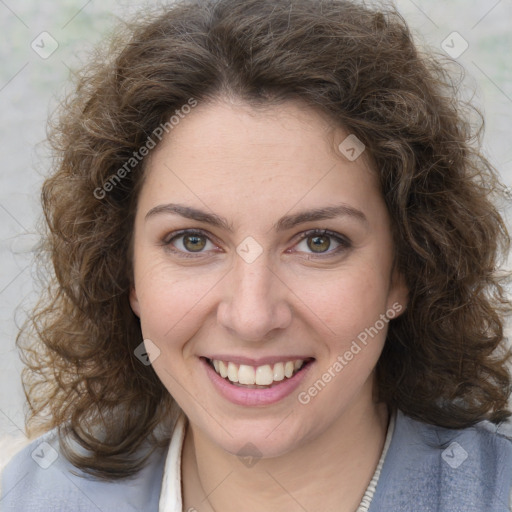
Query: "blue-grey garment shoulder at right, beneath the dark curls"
370 411 512 512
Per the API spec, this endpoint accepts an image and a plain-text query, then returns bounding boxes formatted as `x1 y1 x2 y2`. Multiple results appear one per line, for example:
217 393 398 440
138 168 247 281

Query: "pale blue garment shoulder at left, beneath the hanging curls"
0 430 165 512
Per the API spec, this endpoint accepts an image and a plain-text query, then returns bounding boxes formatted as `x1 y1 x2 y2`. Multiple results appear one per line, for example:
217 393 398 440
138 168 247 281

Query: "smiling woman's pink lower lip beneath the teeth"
201 359 313 406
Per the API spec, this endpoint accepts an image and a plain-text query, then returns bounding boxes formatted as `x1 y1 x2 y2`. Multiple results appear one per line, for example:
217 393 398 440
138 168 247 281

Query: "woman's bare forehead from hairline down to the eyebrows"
138 100 382 222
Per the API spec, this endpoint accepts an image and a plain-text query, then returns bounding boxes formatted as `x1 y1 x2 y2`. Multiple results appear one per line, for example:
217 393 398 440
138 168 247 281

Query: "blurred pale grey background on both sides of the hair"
0 0 512 439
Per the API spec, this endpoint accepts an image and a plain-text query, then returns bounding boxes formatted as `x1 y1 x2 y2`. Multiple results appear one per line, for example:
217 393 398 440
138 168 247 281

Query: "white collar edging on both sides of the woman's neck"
158 412 396 512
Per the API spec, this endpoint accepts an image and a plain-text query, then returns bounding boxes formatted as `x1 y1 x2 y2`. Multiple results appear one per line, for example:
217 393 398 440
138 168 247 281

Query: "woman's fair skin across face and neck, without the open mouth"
130 98 407 512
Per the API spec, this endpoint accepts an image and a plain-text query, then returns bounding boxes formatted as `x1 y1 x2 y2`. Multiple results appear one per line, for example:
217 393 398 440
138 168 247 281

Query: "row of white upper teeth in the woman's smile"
212 359 304 386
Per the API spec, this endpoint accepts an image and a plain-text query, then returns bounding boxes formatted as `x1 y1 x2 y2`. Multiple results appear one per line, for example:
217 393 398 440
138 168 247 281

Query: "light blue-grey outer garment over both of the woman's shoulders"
0 411 512 512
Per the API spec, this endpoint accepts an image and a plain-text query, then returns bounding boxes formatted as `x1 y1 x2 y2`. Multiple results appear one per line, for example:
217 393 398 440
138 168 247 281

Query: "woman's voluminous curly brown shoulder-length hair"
18 0 511 478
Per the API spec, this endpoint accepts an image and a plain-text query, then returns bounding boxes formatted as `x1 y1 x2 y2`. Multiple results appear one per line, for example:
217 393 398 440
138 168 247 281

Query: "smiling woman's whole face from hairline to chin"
130 101 406 456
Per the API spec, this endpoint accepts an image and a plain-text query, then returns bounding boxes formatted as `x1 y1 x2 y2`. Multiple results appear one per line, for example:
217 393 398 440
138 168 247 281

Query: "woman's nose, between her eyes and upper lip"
217 254 292 341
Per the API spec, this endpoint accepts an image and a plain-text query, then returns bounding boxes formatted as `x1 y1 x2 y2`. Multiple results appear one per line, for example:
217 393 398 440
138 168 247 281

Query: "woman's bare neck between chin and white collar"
182 396 389 512
